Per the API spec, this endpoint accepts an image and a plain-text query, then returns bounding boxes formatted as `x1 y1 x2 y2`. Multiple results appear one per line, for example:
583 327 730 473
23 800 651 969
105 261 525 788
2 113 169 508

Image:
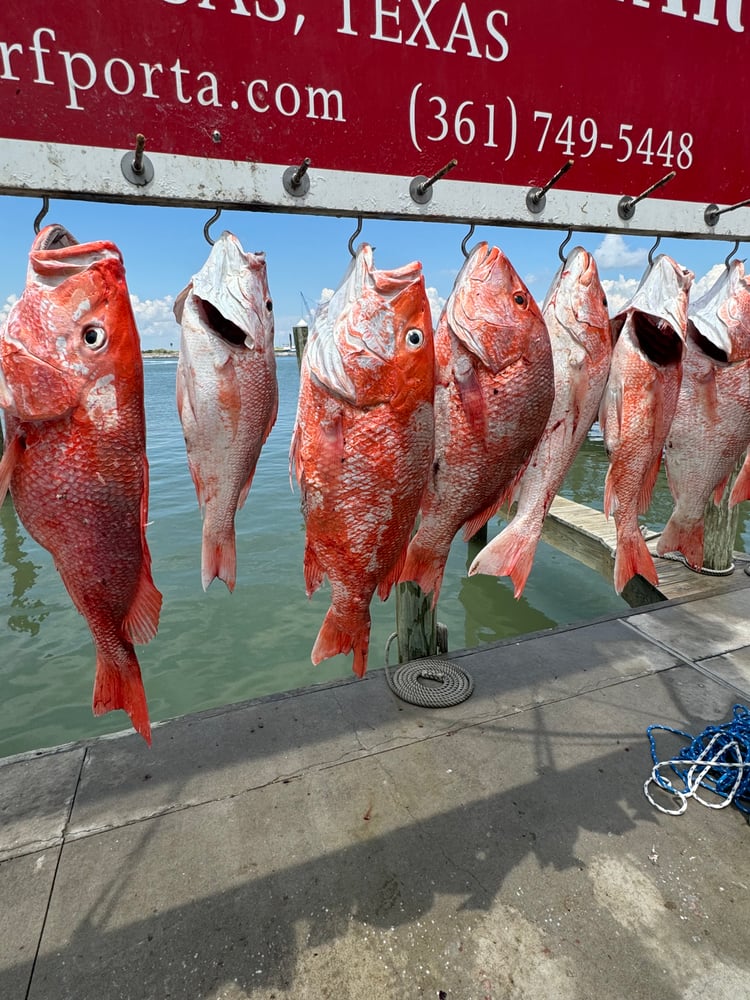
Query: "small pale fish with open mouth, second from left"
174 232 279 591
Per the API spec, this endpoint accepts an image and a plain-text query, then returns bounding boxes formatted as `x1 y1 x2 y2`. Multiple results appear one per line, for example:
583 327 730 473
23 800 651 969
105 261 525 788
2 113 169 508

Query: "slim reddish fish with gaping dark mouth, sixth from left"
599 254 693 594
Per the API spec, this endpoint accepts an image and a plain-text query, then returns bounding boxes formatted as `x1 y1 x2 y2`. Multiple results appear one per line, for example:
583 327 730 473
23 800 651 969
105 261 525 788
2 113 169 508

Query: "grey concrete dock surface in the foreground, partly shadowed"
0 570 750 1000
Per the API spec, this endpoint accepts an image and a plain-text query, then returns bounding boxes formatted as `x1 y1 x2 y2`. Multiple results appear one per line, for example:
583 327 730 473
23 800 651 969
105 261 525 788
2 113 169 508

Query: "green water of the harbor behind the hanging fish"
0 357 745 756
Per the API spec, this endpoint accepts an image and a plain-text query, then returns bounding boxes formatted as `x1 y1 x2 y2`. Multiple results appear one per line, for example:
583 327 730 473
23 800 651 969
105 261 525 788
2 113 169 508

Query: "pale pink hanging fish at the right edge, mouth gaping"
656 260 750 570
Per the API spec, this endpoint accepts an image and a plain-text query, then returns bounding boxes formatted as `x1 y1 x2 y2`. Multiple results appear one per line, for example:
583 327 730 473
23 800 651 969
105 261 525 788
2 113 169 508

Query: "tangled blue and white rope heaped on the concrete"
643 705 750 816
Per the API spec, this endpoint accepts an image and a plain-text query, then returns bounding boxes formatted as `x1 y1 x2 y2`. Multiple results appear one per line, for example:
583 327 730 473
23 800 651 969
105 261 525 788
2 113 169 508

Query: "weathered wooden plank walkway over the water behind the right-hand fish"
542 496 748 607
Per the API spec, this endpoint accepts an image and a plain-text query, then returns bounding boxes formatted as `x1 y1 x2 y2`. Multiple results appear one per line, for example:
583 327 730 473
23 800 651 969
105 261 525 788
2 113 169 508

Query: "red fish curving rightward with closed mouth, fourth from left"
401 243 555 607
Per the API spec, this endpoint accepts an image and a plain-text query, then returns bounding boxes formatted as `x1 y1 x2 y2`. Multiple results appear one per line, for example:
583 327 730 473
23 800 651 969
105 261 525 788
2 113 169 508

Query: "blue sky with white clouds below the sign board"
0 196 746 350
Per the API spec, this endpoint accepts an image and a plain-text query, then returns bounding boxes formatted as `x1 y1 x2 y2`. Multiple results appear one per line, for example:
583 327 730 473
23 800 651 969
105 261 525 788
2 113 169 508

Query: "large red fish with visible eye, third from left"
290 244 435 677
